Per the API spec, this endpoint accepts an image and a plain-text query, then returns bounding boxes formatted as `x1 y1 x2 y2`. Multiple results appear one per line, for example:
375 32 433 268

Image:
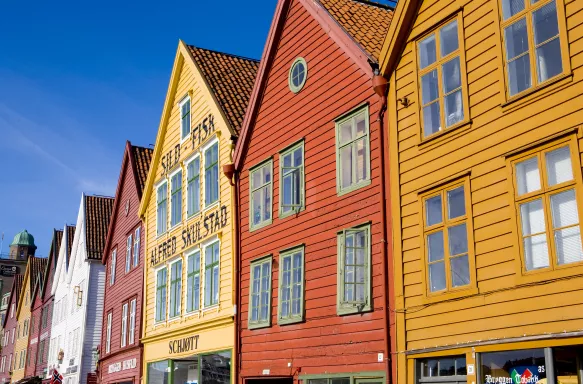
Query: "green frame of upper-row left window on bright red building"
249 158 273 232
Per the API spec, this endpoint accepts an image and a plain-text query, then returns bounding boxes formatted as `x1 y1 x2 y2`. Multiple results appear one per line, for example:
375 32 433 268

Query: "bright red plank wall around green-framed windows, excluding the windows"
238 0 388 380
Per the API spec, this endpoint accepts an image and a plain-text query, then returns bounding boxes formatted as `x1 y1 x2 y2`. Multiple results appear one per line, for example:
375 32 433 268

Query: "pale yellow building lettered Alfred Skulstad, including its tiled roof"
140 42 258 384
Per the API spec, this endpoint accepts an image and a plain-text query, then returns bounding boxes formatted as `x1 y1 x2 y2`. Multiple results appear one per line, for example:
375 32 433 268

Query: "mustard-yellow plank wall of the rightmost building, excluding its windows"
381 0 583 382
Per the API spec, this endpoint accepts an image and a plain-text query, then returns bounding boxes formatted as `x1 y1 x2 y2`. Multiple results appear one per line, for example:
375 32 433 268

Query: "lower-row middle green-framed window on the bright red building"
278 246 304 324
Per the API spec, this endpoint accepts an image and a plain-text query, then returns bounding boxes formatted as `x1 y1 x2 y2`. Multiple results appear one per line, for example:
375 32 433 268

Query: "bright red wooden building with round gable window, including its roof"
235 0 392 384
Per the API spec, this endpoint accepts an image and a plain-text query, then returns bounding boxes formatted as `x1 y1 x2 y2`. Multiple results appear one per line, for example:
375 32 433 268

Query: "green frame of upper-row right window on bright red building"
336 104 371 196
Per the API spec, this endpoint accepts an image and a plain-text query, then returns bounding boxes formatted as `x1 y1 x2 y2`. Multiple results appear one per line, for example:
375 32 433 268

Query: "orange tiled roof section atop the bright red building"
318 0 393 60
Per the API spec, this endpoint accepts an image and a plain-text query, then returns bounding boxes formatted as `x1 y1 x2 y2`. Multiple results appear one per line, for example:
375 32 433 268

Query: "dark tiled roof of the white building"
85 196 114 260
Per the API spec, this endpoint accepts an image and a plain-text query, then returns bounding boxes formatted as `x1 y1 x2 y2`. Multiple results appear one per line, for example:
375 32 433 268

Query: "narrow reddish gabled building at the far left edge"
0 274 24 383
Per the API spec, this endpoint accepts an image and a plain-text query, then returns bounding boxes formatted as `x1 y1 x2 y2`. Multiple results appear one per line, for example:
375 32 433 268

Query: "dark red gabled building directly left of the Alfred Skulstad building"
99 141 152 384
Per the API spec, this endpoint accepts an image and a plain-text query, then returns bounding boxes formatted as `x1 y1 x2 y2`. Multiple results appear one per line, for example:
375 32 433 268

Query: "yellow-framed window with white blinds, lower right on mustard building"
514 143 583 271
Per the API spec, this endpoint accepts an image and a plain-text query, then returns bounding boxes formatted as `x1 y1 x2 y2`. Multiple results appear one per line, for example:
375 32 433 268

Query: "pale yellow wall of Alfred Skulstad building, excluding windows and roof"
142 43 234 364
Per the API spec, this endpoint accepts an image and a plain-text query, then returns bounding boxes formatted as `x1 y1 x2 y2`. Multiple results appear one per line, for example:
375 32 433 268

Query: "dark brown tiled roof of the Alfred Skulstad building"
188 45 259 134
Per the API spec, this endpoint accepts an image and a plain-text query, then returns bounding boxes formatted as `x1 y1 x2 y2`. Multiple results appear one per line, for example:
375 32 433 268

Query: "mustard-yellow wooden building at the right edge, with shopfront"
381 0 583 384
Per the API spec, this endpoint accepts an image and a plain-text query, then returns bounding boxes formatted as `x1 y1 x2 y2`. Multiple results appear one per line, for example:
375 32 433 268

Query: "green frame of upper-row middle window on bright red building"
279 139 306 219
